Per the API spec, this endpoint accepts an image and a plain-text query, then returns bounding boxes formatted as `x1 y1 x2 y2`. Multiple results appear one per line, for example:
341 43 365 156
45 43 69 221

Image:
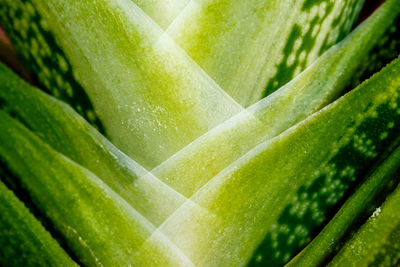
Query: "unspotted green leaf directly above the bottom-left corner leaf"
0 111 191 266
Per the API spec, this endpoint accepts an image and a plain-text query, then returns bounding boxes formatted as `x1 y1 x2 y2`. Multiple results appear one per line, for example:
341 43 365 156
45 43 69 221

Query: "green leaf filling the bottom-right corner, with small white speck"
328 181 400 266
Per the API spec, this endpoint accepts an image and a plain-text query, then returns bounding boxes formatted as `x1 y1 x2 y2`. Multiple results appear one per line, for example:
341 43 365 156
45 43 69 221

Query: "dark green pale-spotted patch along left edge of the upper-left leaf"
0 0 104 133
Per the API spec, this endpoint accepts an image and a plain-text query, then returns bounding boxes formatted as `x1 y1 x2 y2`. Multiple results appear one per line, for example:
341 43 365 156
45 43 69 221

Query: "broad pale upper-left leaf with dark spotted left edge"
0 0 242 168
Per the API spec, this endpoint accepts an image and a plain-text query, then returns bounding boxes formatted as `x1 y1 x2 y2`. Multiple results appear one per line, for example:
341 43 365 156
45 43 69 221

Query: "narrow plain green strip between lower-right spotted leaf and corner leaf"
288 144 400 266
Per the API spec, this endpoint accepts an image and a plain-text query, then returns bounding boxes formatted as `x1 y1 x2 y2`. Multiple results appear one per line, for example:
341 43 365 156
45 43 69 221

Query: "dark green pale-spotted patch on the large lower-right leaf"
248 60 400 265
